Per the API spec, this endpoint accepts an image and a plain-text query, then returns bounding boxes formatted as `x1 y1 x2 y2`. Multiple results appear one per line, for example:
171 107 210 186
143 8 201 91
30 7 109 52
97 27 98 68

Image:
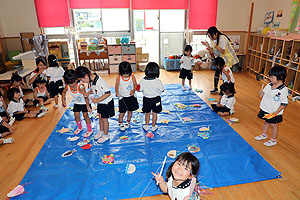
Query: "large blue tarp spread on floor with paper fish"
17 85 280 200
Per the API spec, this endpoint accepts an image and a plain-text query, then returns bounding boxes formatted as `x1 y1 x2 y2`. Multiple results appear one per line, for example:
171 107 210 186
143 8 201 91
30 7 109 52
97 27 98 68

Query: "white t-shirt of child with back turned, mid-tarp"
140 77 165 98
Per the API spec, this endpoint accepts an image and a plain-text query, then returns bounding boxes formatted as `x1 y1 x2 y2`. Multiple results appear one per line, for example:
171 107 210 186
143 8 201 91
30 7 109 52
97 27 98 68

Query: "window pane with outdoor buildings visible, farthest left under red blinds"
74 9 102 32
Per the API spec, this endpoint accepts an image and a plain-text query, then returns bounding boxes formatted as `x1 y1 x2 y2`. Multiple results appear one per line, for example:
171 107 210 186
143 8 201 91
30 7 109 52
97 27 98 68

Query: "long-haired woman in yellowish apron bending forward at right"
202 26 239 94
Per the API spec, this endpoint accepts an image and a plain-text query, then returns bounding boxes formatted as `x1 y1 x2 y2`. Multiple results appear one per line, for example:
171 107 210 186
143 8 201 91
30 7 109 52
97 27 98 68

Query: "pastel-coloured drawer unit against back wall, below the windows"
108 44 136 73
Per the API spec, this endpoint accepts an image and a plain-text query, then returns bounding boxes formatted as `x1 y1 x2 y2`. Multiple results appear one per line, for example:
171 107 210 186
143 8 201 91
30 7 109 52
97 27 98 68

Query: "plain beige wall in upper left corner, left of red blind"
0 0 40 37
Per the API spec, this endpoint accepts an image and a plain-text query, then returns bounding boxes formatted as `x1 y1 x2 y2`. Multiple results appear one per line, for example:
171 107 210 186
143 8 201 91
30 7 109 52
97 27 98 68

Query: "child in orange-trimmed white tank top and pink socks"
62 69 93 137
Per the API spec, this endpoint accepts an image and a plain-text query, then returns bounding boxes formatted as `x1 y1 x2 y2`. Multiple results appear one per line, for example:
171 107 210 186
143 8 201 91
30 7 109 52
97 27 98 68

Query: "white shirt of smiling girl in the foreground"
167 176 191 200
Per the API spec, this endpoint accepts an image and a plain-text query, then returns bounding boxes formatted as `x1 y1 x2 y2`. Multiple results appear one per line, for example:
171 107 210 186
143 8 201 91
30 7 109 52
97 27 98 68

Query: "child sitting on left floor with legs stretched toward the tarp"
7 88 47 121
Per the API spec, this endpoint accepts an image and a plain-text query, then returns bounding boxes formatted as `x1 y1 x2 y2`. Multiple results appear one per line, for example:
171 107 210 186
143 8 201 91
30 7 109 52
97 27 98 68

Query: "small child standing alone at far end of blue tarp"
179 45 194 90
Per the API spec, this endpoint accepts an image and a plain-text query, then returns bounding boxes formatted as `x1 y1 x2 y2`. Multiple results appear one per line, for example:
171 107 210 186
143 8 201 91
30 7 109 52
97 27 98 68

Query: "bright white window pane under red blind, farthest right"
160 10 185 32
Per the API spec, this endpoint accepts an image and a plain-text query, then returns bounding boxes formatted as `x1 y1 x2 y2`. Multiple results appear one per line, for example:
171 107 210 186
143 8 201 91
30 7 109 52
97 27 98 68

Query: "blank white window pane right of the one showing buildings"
102 9 129 32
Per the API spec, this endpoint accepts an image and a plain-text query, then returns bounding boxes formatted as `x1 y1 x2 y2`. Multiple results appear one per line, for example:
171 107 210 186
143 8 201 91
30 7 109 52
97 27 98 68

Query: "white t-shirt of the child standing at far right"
259 83 288 115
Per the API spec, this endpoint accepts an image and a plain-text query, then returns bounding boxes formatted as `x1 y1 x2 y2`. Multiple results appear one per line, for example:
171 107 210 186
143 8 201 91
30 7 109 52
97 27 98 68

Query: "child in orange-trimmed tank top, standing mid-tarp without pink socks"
115 61 139 131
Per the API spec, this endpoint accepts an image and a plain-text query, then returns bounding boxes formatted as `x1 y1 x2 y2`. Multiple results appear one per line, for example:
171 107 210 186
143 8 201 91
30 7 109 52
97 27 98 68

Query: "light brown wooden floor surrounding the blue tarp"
0 70 300 200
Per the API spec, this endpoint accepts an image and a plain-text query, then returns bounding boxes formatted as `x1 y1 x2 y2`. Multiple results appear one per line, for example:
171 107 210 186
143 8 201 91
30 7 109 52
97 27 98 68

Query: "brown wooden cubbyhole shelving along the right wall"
246 34 300 96
